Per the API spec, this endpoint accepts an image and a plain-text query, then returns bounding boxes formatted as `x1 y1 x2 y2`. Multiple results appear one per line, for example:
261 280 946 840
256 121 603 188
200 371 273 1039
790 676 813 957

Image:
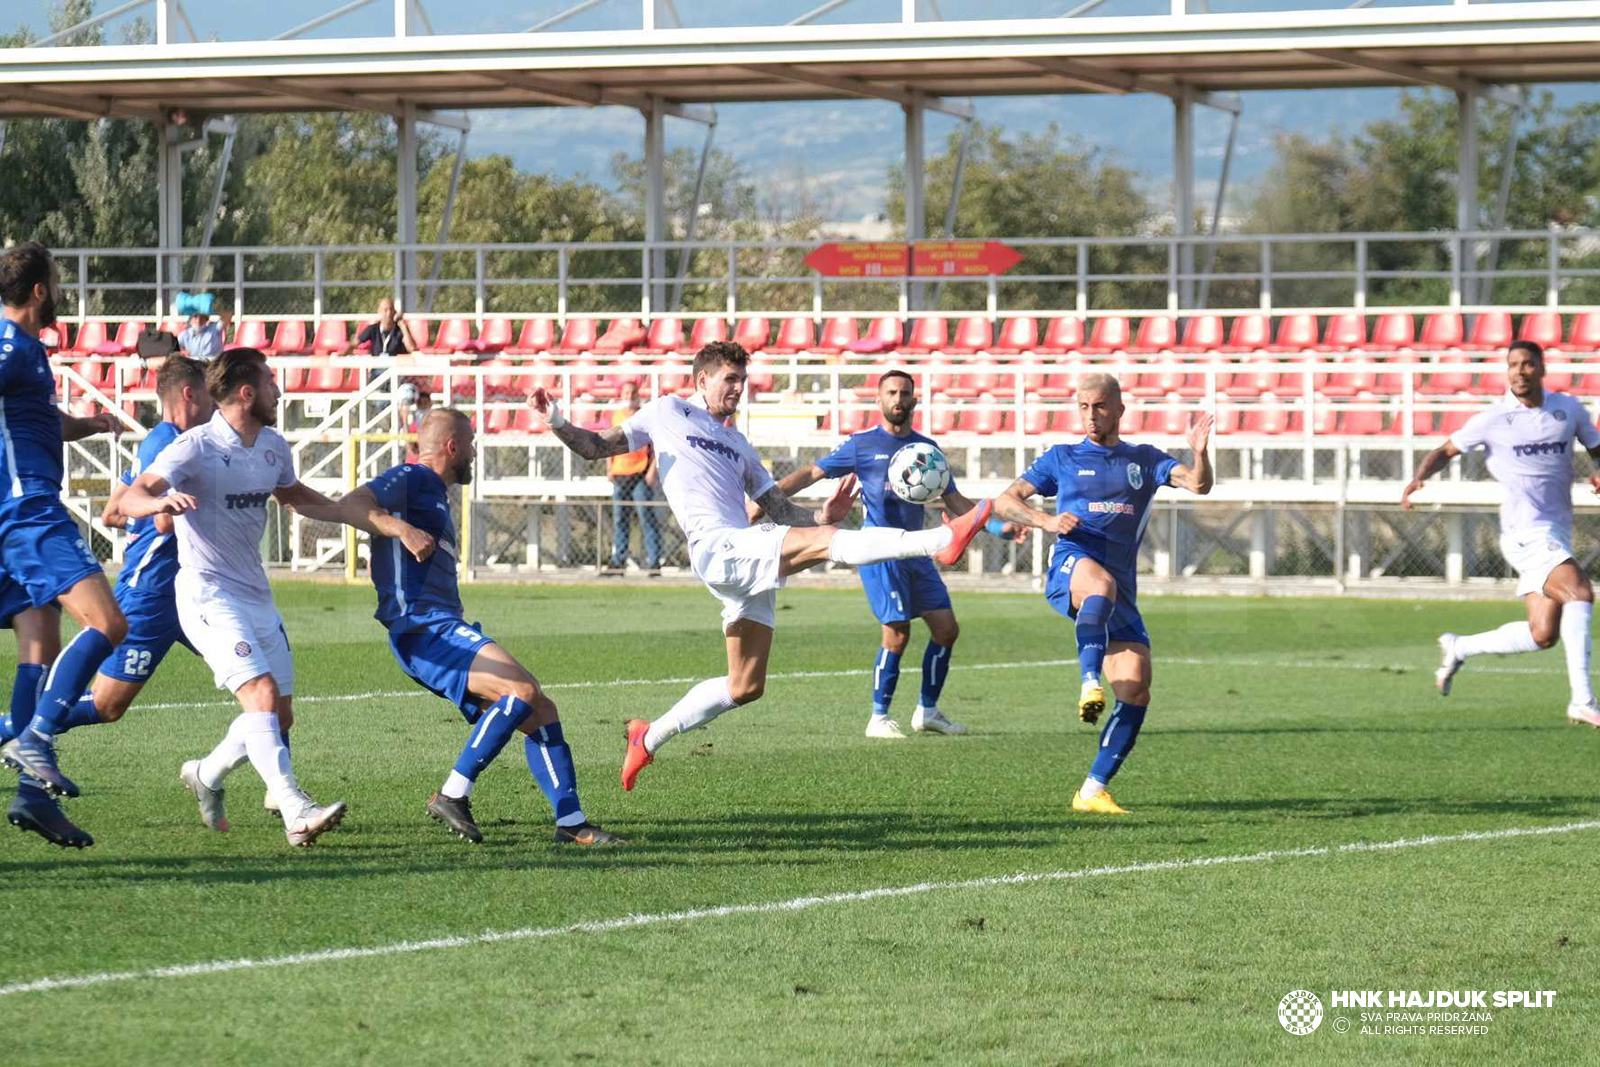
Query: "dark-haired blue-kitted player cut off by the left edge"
0 242 128 848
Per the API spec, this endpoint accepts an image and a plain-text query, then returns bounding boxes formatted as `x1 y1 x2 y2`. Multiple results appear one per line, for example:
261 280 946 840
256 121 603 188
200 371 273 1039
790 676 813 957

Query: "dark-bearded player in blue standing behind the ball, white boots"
778 371 1016 739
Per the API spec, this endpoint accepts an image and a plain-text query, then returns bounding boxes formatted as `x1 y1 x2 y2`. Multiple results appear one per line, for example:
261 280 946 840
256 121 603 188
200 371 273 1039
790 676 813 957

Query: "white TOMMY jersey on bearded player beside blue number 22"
146 411 296 603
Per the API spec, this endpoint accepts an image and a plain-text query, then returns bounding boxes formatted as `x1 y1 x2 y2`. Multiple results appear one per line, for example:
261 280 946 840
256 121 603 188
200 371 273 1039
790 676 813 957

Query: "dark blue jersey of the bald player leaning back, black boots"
366 464 462 625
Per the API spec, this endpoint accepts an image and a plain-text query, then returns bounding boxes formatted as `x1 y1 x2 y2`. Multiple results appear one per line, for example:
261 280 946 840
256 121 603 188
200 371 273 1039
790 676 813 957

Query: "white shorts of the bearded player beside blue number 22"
173 569 294 696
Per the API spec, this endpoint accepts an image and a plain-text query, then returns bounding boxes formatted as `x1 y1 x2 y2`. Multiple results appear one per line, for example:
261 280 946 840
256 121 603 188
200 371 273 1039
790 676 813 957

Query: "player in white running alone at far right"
1400 341 1600 726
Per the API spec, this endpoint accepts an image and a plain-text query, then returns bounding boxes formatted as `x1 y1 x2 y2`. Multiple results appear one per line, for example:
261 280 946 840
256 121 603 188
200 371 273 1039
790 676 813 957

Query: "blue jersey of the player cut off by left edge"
0 318 62 510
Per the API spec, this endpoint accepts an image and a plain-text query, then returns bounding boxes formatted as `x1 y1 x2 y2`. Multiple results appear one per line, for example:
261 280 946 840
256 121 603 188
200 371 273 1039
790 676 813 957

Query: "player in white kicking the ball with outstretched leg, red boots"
528 341 992 789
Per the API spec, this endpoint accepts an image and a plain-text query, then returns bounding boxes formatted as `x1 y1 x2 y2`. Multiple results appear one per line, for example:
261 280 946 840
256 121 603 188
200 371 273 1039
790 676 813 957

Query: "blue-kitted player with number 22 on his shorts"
0 355 213 838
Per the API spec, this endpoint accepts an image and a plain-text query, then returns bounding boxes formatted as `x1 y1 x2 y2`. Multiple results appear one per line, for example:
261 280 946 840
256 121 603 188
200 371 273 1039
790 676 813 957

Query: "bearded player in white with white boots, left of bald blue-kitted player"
122 349 425 845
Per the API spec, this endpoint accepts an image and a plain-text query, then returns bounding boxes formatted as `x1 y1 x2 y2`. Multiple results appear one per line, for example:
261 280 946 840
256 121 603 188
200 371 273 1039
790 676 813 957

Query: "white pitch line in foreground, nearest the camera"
0 819 1600 997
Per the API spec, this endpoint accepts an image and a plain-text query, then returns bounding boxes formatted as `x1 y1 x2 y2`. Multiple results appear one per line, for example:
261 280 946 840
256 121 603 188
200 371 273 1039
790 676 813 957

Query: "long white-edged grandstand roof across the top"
9 0 1600 118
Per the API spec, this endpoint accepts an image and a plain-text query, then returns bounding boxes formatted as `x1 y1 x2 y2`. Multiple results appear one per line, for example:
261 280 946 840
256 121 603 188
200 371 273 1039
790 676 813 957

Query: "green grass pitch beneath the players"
0 582 1600 1067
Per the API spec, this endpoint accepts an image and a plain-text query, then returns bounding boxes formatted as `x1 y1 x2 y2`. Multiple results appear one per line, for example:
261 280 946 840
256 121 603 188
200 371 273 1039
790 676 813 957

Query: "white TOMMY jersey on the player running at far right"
1450 392 1600 537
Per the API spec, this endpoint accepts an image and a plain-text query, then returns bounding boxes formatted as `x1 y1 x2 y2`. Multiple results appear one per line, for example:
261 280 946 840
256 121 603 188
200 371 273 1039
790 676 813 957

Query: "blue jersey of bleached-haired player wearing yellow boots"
1022 438 1178 601
